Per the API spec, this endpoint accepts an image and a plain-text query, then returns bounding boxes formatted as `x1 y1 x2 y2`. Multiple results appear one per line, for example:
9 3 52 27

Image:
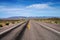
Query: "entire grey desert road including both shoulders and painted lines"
0 20 60 40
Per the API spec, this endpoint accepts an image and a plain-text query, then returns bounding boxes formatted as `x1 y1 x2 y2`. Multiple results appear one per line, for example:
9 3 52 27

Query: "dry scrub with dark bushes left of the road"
0 19 24 27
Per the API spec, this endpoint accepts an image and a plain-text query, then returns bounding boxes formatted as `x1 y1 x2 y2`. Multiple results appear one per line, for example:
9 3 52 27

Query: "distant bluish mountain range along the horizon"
0 16 60 20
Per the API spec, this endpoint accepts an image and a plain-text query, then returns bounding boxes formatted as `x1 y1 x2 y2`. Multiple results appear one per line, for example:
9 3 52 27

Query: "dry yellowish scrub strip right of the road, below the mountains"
35 18 60 24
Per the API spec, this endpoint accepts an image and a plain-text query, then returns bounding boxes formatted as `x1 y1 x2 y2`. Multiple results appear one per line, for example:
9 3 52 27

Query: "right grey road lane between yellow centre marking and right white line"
19 21 60 40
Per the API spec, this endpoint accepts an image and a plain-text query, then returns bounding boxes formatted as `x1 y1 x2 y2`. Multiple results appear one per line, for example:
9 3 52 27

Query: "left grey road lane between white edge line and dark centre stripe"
0 23 26 40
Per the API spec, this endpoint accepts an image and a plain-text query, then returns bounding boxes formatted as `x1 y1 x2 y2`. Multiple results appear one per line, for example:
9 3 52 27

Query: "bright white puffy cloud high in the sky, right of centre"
26 4 52 9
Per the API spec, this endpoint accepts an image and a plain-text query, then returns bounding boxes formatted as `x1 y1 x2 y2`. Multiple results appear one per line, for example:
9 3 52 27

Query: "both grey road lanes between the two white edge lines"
1 20 60 40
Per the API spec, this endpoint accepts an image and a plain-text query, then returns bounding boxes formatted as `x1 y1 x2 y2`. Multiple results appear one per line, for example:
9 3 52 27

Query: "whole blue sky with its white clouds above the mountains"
0 0 60 18
